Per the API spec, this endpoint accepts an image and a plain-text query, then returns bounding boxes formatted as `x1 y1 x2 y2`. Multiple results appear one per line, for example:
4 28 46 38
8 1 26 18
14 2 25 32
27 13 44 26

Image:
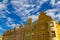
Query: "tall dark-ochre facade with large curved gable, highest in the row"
34 12 52 40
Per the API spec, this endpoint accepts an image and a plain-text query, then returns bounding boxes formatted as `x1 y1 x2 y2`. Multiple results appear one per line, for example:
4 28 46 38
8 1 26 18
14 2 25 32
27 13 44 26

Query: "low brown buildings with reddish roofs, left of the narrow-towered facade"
3 25 24 40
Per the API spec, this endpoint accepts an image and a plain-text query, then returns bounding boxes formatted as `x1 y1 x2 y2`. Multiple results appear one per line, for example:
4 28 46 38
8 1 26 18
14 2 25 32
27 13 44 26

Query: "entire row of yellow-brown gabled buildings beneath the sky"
3 12 60 40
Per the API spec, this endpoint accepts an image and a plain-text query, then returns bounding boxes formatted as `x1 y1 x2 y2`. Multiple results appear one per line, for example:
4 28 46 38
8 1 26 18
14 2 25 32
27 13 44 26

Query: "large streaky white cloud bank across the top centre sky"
11 0 48 17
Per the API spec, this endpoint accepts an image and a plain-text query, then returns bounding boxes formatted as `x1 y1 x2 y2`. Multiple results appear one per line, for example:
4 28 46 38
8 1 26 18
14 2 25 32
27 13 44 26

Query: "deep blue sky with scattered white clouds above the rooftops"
0 0 60 35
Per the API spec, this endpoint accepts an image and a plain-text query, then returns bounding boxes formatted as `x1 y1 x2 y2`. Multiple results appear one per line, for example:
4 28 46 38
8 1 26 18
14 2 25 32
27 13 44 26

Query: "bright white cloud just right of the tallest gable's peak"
46 8 60 22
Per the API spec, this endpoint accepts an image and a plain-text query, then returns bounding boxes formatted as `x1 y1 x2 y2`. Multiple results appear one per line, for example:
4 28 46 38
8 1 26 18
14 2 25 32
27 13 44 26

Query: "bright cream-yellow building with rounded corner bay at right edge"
48 20 60 40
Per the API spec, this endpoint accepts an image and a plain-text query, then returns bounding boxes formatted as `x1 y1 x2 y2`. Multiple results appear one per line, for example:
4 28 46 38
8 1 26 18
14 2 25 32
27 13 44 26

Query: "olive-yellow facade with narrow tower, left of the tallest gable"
24 18 34 40
